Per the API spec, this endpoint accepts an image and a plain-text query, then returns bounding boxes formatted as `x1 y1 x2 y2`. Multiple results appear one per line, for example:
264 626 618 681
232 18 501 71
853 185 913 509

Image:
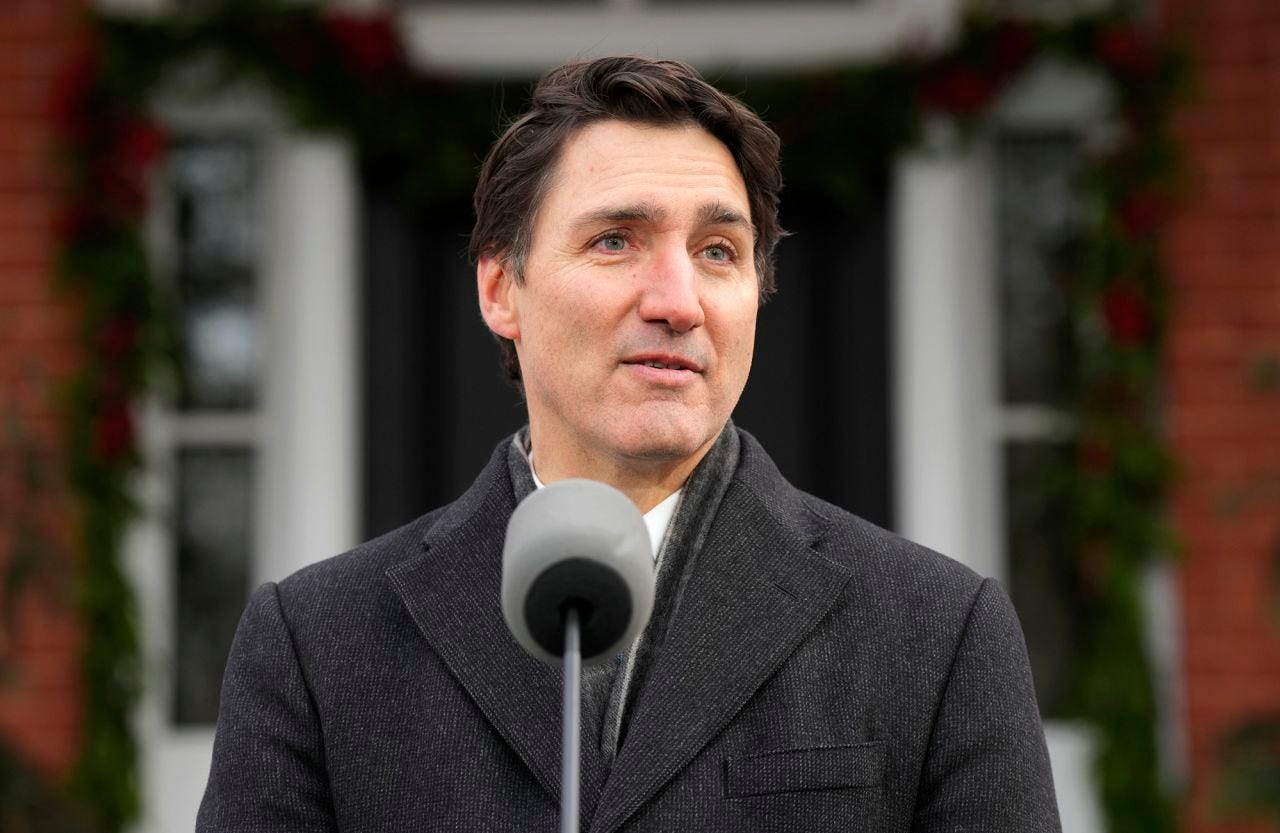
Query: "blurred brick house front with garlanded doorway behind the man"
0 0 1280 833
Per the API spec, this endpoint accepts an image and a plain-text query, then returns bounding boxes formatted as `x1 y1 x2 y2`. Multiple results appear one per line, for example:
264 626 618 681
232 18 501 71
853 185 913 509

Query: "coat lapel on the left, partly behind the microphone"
387 444 599 813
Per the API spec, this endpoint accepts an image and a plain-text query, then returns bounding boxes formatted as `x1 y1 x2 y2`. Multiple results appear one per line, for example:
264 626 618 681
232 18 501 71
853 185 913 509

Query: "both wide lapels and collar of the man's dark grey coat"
388 431 849 833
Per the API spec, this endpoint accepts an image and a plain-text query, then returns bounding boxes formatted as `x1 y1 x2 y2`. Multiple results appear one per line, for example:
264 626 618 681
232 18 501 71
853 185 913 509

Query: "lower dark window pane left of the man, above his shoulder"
174 448 253 724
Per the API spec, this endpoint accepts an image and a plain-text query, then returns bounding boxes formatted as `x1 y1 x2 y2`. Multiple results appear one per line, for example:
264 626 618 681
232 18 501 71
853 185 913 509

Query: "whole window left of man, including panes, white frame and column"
128 125 360 833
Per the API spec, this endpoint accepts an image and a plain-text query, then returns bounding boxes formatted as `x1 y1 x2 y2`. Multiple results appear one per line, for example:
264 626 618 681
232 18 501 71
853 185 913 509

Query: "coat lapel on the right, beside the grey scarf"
590 434 849 833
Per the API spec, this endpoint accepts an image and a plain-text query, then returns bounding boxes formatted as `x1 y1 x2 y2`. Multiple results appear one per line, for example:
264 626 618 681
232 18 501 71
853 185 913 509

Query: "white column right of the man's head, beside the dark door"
892 148 1004 577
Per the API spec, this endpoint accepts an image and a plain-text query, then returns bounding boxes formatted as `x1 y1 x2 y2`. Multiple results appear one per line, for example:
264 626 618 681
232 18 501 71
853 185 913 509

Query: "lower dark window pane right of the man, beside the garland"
1005 443 1080 718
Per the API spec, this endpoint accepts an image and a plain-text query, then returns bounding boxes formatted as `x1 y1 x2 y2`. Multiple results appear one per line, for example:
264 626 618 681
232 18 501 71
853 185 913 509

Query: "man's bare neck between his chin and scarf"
529 430 719 513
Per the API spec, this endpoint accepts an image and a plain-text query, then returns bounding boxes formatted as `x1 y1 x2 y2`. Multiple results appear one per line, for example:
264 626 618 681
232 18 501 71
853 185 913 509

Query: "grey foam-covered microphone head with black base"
502 479 654 665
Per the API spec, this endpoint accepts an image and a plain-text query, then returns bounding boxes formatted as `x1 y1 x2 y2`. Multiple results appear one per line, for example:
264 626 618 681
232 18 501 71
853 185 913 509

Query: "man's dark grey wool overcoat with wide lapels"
196 432 1060 833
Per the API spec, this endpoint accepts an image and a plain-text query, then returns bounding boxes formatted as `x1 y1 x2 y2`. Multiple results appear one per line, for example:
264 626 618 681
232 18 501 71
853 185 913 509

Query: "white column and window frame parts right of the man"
892 64 1185 833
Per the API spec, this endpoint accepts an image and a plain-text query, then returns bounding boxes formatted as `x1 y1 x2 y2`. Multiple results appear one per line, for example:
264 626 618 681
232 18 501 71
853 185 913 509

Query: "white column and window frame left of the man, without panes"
125 90 360 833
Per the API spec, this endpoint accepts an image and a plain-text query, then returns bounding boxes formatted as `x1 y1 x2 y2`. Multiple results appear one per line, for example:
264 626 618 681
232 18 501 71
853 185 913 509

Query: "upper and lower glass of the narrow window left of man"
166 138 261 726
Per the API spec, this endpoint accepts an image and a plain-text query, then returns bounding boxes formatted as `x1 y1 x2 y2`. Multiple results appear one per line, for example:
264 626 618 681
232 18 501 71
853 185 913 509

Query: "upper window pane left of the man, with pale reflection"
169 139 260 408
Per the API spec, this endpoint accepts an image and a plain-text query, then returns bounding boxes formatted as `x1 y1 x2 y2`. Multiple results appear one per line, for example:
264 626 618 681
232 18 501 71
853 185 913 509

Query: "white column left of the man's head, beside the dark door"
255 136 360 581
